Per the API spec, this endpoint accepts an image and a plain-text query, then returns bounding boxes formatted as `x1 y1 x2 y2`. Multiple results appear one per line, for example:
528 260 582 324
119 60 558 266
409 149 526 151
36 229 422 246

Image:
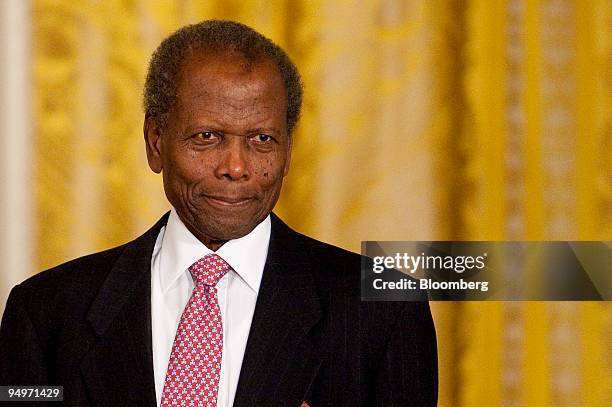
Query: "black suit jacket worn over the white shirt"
0 215 437 407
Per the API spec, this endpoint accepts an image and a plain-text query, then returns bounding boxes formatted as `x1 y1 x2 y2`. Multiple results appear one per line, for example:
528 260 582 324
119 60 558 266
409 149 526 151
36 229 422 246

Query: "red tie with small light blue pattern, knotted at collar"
161 253 230 407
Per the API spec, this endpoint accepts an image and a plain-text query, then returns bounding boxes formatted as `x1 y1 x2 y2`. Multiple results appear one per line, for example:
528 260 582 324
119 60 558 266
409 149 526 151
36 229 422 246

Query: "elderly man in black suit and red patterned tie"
0 21 437 407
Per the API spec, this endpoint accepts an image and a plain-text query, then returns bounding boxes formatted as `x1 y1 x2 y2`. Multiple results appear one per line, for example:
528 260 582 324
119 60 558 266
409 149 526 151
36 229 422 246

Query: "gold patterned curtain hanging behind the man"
33 0 612 406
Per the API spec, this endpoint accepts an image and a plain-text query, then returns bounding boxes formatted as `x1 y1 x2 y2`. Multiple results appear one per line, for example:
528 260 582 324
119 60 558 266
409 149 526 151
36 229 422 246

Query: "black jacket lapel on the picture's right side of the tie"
234 214 321 406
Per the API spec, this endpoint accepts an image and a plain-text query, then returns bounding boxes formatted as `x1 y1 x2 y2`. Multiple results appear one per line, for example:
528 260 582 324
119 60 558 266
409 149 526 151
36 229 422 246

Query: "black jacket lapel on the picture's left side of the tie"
81 214 168 405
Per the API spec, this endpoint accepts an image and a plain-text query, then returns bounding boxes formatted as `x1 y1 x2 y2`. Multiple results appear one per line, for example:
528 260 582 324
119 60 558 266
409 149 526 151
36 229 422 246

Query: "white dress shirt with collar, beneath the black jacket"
151 209 271 407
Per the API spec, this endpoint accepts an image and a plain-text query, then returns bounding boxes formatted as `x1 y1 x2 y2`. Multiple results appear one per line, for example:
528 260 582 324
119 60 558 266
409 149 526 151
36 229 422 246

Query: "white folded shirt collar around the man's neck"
160 208 271 294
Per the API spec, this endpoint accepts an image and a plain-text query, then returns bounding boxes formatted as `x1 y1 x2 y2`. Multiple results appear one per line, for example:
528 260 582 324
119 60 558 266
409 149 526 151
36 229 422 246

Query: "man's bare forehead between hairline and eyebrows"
177 50 286 102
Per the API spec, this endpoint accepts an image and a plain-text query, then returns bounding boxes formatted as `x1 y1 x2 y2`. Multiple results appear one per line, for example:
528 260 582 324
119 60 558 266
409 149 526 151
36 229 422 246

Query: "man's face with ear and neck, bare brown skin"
144 50 291 250
